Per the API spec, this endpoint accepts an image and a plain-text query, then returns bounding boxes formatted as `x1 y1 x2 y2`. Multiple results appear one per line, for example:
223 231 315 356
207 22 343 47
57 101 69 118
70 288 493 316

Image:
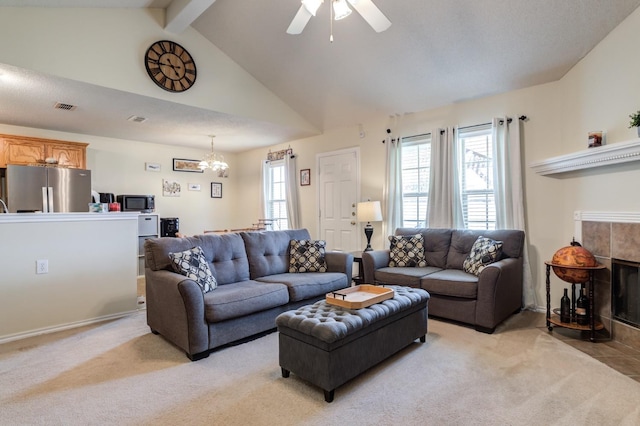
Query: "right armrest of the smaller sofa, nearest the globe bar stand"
476 257 523 330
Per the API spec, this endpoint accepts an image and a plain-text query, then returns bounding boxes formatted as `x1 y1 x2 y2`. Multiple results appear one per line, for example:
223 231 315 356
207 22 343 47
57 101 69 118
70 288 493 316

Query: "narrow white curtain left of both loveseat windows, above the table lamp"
382 136 402 236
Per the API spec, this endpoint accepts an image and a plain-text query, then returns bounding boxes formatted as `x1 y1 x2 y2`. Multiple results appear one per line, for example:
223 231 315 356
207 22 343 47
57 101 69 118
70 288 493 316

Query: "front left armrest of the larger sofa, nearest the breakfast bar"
145 268 209 358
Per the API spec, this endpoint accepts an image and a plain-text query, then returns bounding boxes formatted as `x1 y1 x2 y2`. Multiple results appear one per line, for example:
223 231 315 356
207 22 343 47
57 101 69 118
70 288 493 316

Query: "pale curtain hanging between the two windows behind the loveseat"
427 128 464 228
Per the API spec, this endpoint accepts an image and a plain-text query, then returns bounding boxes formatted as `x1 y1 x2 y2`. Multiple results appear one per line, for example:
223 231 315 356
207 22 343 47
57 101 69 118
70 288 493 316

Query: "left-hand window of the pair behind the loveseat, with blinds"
401 134 431 228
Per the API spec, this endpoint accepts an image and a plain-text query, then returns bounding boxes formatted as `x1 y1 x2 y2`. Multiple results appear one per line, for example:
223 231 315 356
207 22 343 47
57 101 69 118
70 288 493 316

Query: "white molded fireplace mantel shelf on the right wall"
529 139 640 176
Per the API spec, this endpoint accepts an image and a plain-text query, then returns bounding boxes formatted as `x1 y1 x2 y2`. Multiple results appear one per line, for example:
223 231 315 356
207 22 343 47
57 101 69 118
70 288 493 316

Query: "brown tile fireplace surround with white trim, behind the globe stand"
574 211 640 350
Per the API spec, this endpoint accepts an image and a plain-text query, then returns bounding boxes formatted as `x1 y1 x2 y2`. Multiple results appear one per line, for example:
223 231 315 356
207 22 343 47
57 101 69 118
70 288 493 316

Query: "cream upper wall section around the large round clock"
0 7 315 131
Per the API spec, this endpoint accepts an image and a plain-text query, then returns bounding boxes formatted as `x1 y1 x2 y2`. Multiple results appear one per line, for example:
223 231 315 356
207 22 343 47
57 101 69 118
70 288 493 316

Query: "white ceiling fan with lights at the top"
287 0 391 34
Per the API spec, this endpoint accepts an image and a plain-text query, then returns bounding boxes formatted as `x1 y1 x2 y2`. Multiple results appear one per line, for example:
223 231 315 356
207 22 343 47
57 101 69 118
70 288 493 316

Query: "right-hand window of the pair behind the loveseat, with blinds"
458 124 496 229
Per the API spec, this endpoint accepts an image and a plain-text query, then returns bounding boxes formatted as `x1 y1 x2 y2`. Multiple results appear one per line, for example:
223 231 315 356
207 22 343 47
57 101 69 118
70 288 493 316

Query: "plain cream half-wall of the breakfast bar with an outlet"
0 212 139 343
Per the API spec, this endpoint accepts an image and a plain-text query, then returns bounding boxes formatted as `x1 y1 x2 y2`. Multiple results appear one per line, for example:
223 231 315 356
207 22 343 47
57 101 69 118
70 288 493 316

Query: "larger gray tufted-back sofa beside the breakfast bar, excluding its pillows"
144 229 353 360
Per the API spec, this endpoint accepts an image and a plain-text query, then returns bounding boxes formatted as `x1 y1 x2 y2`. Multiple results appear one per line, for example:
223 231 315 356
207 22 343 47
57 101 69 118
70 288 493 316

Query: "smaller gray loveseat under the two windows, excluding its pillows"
362 228 524 333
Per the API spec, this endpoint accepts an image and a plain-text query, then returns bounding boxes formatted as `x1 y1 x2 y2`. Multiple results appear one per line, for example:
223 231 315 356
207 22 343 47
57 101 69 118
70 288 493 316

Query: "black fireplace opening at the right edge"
611 259 640 328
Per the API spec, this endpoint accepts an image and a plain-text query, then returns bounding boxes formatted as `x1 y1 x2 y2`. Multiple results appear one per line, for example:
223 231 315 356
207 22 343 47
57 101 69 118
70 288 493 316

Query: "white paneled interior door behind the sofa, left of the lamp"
318 148 360 252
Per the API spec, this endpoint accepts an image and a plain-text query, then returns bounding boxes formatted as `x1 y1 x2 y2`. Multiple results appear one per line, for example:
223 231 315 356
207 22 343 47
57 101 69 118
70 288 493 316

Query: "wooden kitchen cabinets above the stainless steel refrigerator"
0 135 89 169
